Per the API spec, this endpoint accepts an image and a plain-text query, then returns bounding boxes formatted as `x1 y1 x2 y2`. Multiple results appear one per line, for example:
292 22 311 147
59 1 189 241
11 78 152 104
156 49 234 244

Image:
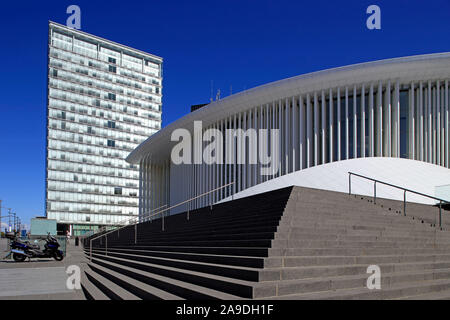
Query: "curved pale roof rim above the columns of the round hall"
126 52 450 163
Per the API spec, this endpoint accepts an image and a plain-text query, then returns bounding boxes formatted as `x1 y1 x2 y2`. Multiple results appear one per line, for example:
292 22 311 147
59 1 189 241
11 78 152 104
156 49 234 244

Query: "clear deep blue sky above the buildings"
0 0 450 228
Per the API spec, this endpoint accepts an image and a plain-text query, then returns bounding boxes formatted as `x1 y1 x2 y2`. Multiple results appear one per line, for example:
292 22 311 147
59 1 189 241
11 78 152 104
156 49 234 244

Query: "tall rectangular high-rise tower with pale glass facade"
46 22 162 235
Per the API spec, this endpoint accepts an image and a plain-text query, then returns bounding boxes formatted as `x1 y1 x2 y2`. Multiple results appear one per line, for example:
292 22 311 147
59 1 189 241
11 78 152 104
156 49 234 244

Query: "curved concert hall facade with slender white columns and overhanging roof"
127 53 450 218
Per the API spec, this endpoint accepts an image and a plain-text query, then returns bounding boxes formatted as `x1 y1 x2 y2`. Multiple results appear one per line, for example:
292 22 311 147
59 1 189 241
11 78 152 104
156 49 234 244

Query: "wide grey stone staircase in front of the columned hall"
82 187 450 300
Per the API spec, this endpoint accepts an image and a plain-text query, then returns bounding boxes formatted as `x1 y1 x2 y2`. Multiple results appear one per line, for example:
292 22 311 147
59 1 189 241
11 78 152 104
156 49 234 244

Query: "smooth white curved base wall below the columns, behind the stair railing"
221 157 450 204
